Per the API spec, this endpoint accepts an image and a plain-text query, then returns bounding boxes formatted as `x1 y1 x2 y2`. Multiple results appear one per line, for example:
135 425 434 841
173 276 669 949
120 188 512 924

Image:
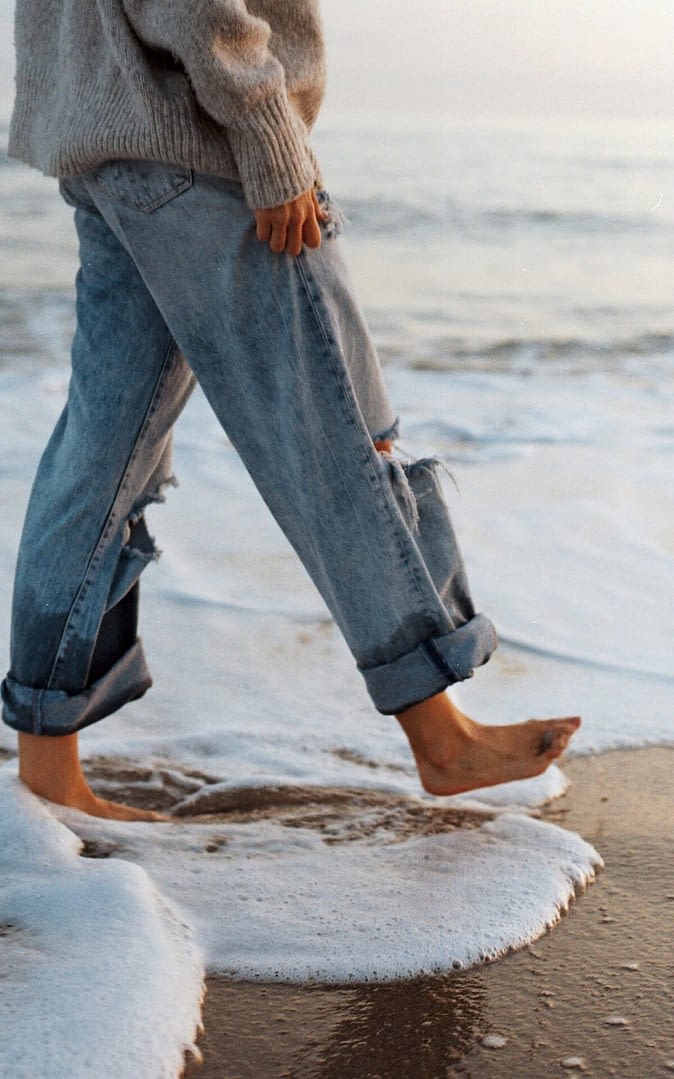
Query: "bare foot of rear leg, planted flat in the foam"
18 734 169 821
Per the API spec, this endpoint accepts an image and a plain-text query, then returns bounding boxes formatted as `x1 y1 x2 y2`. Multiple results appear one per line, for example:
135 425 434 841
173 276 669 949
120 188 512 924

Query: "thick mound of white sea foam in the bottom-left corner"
0 769 204 1079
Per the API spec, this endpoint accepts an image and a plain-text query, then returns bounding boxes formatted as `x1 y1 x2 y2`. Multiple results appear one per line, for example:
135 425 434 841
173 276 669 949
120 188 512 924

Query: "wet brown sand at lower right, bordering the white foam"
184 749 674 1079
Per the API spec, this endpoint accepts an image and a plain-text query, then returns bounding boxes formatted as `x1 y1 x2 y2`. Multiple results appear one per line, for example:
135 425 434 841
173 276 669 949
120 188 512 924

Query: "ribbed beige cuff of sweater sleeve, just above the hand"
228 95 317 209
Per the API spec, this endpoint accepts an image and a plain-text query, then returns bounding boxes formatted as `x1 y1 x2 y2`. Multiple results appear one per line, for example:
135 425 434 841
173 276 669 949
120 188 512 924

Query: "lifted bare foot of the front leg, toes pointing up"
397 694 580 794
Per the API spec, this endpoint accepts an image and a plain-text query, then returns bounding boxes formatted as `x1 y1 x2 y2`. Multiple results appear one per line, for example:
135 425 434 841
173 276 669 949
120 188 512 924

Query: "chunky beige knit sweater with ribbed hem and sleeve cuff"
10 0 325 208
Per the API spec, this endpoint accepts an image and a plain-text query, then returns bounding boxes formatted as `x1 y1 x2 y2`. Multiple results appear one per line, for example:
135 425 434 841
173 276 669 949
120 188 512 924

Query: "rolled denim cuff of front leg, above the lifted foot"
361 614 498 715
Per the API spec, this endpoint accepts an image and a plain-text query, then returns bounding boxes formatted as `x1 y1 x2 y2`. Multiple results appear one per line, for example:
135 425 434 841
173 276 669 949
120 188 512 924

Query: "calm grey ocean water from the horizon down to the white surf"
0 111 674 372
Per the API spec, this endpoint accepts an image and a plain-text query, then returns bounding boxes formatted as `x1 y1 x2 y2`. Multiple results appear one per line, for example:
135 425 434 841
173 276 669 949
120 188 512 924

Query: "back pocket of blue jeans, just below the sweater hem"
92 161 192 214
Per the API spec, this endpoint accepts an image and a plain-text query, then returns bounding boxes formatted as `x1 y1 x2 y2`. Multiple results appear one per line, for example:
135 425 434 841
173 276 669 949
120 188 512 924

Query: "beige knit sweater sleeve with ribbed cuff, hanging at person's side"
123 0 316 208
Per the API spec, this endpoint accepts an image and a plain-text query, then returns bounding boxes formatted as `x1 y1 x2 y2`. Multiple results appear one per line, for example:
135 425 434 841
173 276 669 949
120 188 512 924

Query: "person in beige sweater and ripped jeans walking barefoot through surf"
2 0 580 819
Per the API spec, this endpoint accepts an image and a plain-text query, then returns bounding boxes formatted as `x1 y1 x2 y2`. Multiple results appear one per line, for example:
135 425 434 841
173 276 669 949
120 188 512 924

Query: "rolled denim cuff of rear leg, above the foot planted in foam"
2 641 152 735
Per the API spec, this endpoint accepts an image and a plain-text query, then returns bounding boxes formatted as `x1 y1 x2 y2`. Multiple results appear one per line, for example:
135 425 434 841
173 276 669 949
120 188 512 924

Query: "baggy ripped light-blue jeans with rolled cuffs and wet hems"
2 162 496 735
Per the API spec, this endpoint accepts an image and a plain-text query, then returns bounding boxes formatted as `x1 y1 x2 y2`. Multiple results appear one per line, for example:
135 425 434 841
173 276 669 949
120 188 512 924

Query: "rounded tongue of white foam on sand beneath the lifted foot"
52 789 602 982
